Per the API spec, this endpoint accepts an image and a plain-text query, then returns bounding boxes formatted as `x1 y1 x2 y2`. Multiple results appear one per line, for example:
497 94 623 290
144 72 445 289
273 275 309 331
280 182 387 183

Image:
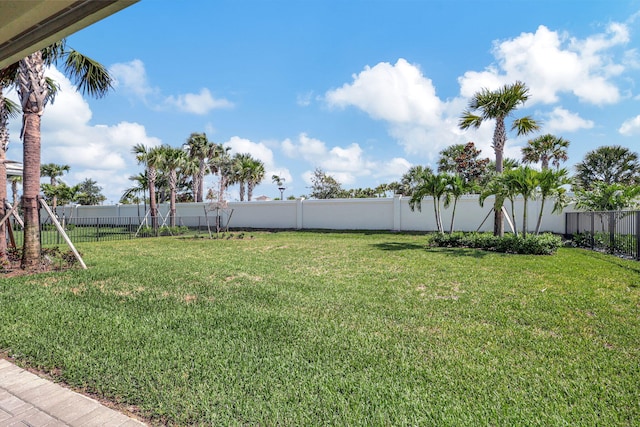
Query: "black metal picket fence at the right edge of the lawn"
565 211 640 260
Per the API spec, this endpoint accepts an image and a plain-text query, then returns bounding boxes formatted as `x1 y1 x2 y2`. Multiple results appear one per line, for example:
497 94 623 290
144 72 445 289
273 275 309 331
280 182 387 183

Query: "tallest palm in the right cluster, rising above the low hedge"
459 81 539 236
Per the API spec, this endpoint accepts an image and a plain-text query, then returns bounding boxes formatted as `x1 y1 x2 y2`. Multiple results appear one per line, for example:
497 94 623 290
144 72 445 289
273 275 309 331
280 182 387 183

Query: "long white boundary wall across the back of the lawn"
50 195 572 234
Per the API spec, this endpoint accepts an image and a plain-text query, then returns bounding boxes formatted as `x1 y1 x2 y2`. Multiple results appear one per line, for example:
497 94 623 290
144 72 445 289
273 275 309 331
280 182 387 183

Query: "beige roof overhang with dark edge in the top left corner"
0 0 139 68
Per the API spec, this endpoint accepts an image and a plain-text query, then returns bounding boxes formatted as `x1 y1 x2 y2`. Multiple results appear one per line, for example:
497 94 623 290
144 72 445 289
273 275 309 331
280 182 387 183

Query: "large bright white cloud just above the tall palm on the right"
459 23 629 105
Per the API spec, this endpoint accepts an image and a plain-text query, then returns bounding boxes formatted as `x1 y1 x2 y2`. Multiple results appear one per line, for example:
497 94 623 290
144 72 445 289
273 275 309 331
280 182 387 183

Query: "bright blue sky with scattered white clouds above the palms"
8 0 640 202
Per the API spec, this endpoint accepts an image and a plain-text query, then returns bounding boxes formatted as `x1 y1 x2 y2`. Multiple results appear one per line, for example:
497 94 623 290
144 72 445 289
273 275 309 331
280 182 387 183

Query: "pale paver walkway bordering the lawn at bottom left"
0 359 145 427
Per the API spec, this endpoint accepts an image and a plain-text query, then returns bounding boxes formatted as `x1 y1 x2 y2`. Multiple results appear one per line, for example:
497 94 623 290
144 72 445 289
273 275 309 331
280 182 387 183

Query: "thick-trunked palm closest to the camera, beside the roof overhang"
17 40 112 268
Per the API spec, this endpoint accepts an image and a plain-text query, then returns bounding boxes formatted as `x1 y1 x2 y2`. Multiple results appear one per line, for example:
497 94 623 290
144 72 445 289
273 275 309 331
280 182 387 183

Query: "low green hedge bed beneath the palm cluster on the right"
429 232 562 255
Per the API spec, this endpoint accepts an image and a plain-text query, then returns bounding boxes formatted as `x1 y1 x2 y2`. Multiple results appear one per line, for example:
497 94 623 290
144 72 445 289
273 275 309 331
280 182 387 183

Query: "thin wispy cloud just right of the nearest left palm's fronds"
109 59 233 115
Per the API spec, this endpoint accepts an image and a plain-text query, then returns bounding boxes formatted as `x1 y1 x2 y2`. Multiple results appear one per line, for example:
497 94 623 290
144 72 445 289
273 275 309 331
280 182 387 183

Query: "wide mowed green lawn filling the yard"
0 232 640 426
